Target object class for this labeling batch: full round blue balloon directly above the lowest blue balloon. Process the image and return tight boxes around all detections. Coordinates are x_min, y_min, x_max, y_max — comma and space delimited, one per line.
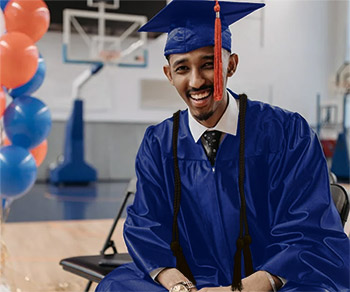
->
4, 95, 52, 149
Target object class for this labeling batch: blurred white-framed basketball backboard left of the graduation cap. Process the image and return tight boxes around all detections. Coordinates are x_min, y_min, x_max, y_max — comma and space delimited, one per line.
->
63, 0, 147, 67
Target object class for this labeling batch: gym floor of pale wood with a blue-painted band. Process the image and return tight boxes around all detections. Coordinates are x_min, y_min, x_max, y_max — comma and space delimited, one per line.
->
0, 181, 350, 292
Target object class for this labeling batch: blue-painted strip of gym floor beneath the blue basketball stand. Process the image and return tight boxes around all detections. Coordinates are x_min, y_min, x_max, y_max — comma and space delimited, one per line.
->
6, 181, 128, 222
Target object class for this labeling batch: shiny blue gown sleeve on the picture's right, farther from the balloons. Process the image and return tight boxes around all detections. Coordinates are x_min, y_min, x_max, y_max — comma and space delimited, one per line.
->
259, 114, 350, 291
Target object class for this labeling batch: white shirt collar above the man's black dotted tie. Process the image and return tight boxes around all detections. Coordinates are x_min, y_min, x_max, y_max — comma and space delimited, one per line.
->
188, 92, 239, 143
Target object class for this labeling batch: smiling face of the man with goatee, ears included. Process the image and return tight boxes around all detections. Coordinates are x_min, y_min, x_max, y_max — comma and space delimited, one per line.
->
164, 47, 238, 127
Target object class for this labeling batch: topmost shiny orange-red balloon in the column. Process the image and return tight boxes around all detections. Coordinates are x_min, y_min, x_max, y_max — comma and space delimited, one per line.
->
4, 0, 50, 43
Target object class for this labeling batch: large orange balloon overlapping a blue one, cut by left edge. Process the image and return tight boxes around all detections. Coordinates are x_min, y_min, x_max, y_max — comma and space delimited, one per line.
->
0, 32, 39, 88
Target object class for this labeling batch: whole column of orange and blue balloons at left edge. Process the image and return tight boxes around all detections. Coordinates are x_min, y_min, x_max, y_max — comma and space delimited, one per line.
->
0, 0, 51, 210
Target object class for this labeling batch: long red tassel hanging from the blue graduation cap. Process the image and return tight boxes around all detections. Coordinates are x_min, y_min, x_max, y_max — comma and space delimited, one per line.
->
214, 0, 223, 101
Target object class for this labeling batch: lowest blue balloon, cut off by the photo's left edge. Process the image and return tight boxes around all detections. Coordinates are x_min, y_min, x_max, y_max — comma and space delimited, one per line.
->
0, 145, 37, 198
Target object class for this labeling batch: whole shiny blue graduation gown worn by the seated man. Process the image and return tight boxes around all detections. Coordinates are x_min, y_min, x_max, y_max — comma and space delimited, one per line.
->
97, 100, 350, 292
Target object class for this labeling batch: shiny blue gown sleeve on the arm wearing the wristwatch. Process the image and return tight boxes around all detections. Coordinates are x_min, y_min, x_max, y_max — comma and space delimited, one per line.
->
124, 127, 176, 275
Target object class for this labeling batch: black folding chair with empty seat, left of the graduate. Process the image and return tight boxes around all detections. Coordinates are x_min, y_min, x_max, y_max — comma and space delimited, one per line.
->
60, 178, 136, 291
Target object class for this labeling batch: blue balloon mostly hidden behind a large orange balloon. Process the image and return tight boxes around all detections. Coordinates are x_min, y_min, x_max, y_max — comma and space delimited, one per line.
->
9, 55, 46, 98
